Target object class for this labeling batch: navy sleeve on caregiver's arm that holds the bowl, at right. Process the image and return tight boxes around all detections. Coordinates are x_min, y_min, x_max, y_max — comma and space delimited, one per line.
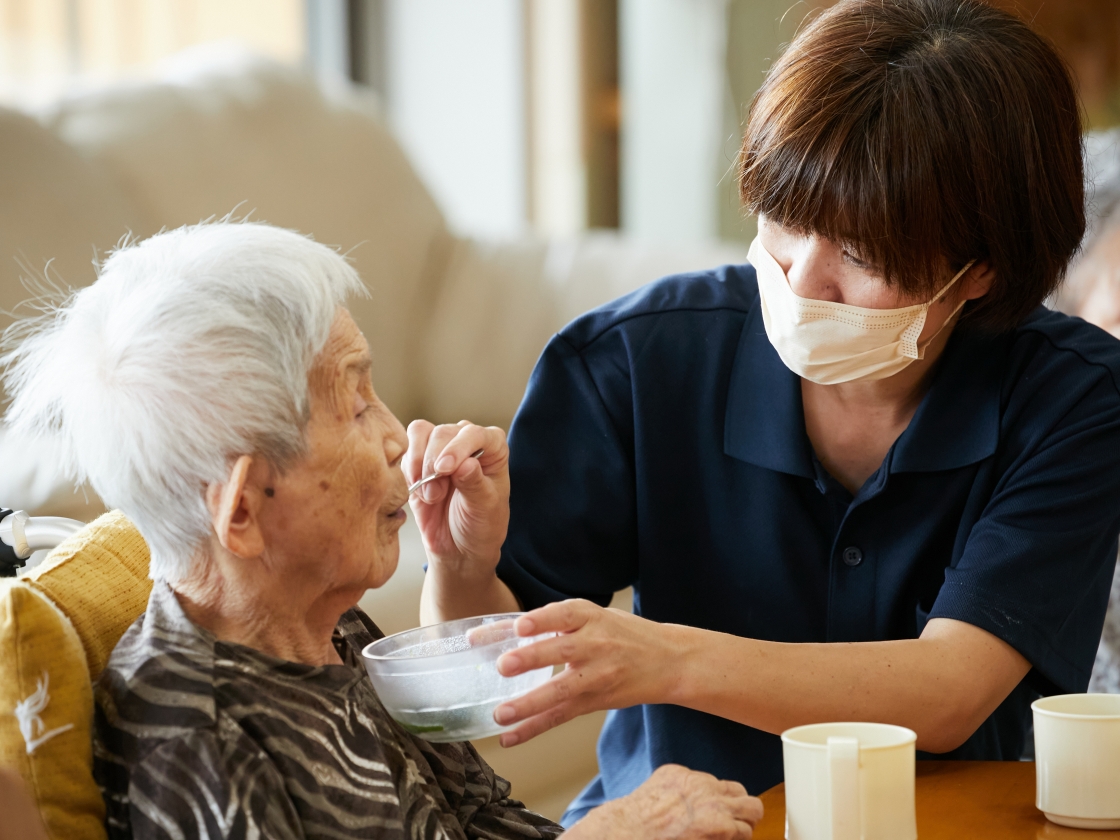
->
930, 376, 1120, 693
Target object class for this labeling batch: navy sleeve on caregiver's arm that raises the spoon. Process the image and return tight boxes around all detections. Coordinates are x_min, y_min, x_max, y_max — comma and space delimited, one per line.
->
497, 332, 637, 608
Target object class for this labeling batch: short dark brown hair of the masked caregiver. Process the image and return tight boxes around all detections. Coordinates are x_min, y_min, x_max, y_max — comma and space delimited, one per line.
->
739, 0, 1085, 329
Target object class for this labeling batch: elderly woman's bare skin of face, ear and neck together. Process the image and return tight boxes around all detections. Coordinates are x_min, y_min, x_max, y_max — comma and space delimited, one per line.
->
179, 309, 408, 665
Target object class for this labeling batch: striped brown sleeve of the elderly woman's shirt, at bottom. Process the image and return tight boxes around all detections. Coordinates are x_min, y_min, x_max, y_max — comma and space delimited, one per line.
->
123, 730, 304, 840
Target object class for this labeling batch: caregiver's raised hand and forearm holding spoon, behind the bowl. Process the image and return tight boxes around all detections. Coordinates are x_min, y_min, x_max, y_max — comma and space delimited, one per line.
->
402, 420, 521, 625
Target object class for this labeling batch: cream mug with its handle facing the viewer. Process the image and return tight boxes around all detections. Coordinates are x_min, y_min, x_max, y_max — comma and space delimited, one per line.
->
782, 724, 917, 840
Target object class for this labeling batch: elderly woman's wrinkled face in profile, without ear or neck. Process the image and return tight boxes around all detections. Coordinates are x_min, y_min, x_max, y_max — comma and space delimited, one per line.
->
262, 309, 408, 595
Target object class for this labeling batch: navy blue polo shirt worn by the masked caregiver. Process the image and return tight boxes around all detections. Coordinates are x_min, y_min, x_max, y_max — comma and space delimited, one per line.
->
498, 264, 1120, 815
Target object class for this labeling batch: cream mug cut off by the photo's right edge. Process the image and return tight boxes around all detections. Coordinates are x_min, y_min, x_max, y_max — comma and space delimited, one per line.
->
1030, 694, 1120, 829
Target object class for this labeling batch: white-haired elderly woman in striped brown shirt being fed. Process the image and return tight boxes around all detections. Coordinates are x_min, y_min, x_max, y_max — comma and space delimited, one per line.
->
7, 224, 760, 839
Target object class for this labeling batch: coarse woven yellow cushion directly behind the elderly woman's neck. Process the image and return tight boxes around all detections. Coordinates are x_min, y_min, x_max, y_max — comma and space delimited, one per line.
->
22, 511, 151, 680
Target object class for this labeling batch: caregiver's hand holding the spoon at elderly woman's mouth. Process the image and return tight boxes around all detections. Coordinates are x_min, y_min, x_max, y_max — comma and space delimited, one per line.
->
403, 420, 510, 573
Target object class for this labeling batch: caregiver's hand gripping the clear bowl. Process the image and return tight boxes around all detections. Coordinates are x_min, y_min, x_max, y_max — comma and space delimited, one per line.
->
494, 600, 679, 747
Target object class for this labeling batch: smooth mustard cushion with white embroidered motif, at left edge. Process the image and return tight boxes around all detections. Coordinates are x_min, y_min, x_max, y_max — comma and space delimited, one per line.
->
0, 580, 105, 840
